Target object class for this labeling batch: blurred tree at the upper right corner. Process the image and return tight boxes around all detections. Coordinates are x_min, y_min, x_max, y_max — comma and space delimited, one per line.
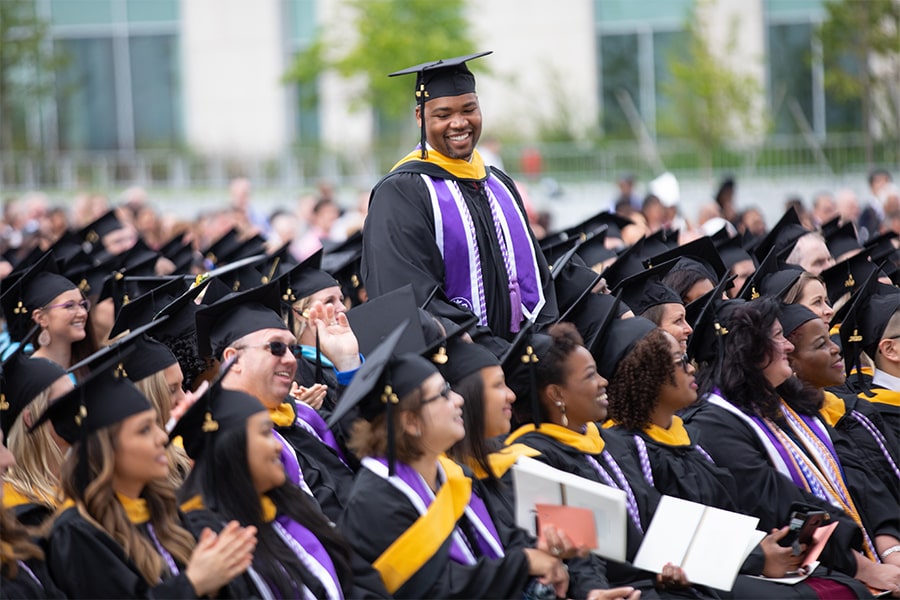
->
816, 0, 900, 165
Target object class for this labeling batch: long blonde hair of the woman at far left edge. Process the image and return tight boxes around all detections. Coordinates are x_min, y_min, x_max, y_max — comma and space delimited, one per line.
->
5, 387, 65, 508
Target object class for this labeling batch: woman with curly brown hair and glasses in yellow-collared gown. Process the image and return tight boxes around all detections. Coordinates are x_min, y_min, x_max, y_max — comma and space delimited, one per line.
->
609, 322, 866, 598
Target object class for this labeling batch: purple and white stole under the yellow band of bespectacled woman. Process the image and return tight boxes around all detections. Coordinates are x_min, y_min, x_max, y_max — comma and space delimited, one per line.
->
362, 457, 504, 565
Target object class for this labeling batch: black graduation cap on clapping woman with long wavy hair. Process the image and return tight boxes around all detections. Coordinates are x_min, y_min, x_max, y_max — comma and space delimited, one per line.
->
30, 348, 153, 446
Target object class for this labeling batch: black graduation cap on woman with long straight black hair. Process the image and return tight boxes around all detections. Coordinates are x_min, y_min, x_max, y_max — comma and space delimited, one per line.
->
169, 363, 266, 461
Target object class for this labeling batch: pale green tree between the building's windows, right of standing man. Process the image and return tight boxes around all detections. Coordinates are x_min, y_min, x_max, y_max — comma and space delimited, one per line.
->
657, 1, 765, 175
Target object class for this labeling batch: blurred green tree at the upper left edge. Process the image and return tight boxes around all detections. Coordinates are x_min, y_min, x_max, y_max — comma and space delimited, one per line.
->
0, 0, 65, 150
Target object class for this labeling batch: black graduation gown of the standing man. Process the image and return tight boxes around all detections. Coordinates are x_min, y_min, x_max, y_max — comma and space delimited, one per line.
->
362, 161, 558, 349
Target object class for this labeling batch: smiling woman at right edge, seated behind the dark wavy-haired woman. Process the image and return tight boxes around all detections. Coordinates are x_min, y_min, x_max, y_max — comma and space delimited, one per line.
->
781, 304, 900, 507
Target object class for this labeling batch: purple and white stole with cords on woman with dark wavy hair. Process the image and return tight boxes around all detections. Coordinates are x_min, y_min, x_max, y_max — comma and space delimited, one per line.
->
706, 393, 880, 562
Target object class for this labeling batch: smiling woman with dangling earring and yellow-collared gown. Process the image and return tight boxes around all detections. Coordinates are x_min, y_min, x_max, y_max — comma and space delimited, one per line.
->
504, 317, 704, 598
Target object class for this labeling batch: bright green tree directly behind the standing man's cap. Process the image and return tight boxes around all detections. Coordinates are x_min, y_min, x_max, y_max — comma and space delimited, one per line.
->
285, 0, 477, 143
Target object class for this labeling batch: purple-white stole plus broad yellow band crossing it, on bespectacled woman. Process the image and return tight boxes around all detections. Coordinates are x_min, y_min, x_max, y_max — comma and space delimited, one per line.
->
362, 456, 504, 594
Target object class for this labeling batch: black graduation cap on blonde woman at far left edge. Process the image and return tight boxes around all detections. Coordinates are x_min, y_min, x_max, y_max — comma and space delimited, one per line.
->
0, 326, 66, 438
